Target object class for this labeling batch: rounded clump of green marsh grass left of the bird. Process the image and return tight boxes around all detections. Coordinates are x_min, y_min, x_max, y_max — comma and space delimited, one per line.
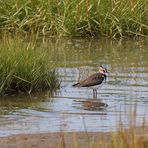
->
0, 39, 59, 95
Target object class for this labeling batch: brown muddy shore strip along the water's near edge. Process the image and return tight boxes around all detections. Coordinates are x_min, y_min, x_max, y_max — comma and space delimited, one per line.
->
0, 126, 148, 148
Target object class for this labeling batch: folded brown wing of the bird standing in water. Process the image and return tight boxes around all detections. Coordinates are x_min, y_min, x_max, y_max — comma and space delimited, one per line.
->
77, 73, 105, 87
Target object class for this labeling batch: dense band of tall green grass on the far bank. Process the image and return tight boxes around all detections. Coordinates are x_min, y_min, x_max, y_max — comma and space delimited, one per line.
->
0, 0, 148, 37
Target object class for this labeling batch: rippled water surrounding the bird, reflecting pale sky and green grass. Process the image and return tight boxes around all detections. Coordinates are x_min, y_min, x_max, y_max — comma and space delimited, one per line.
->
0, 39, 148, 136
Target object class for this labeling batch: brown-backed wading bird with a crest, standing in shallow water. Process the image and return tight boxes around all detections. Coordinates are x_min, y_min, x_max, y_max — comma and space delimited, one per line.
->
72, 65, 108, 99
